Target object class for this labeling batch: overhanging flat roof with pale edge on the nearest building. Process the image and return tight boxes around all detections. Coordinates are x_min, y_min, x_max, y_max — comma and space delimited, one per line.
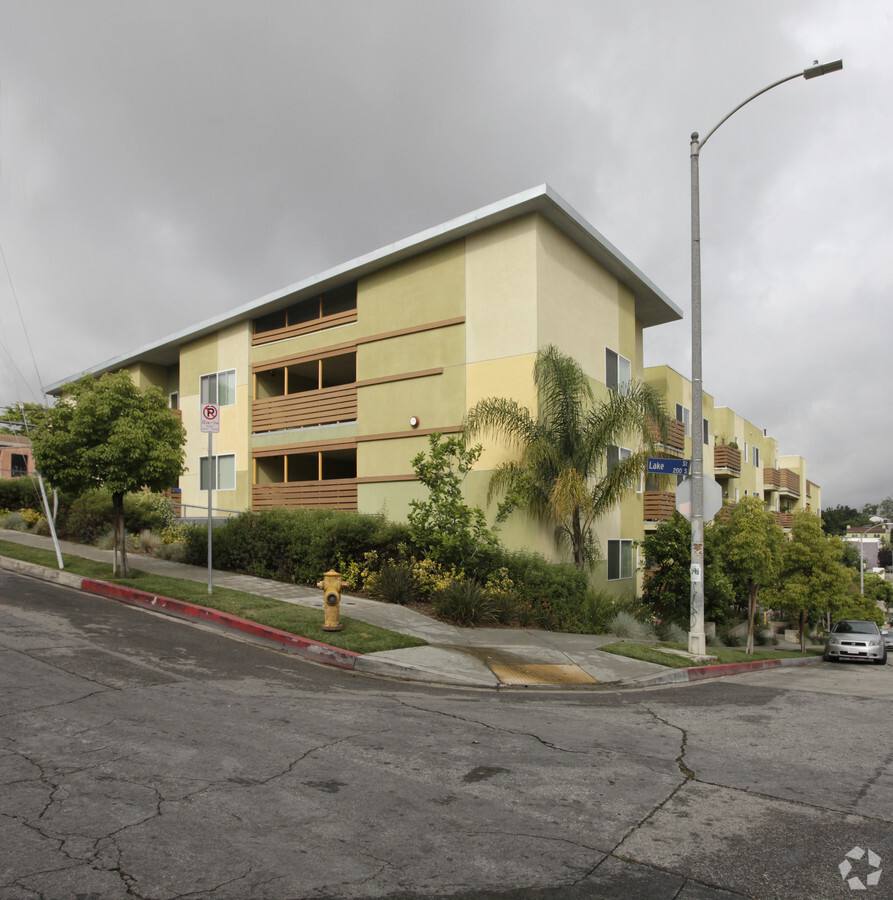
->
45, 184, 682, 394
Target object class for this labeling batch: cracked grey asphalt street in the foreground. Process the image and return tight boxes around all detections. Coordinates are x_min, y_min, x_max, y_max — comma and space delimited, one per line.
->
0, 572, 893, 900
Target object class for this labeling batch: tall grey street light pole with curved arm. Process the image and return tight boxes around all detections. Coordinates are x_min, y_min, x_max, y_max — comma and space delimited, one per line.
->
688, 59, 843, 655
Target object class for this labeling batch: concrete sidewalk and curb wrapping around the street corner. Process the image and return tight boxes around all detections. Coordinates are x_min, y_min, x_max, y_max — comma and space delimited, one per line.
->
0, 529, 820, 688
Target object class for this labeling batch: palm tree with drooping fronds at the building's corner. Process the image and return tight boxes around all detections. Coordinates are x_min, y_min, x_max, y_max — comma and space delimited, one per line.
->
465, 345, 667, 567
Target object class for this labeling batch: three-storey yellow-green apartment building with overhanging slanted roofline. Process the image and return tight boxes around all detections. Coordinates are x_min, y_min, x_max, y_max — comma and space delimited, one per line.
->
48, 186, 684, 591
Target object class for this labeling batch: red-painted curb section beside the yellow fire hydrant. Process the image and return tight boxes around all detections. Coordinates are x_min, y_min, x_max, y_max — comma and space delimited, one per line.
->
81, 578, 361, 669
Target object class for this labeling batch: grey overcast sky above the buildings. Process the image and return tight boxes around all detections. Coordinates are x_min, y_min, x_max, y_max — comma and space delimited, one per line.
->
0, 0, 893, 507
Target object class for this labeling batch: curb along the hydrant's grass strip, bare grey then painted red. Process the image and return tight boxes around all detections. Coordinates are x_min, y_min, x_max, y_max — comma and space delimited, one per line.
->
0, 557, 361, 669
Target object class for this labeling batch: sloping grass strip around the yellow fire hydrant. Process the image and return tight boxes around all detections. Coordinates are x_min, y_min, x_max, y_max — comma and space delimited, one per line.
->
0, 541, 427, 653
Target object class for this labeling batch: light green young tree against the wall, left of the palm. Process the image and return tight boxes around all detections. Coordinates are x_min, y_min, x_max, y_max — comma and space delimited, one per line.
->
407, 433, 498, 569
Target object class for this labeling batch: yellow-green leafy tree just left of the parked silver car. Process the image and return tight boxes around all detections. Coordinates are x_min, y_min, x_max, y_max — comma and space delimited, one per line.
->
767, 510, 853, 651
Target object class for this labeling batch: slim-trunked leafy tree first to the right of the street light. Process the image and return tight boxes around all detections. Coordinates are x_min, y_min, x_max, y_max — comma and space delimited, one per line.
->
715, 497, 784, 653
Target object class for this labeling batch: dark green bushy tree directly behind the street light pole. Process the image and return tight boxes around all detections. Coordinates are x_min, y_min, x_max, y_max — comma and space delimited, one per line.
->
642, 512, 733, 629
